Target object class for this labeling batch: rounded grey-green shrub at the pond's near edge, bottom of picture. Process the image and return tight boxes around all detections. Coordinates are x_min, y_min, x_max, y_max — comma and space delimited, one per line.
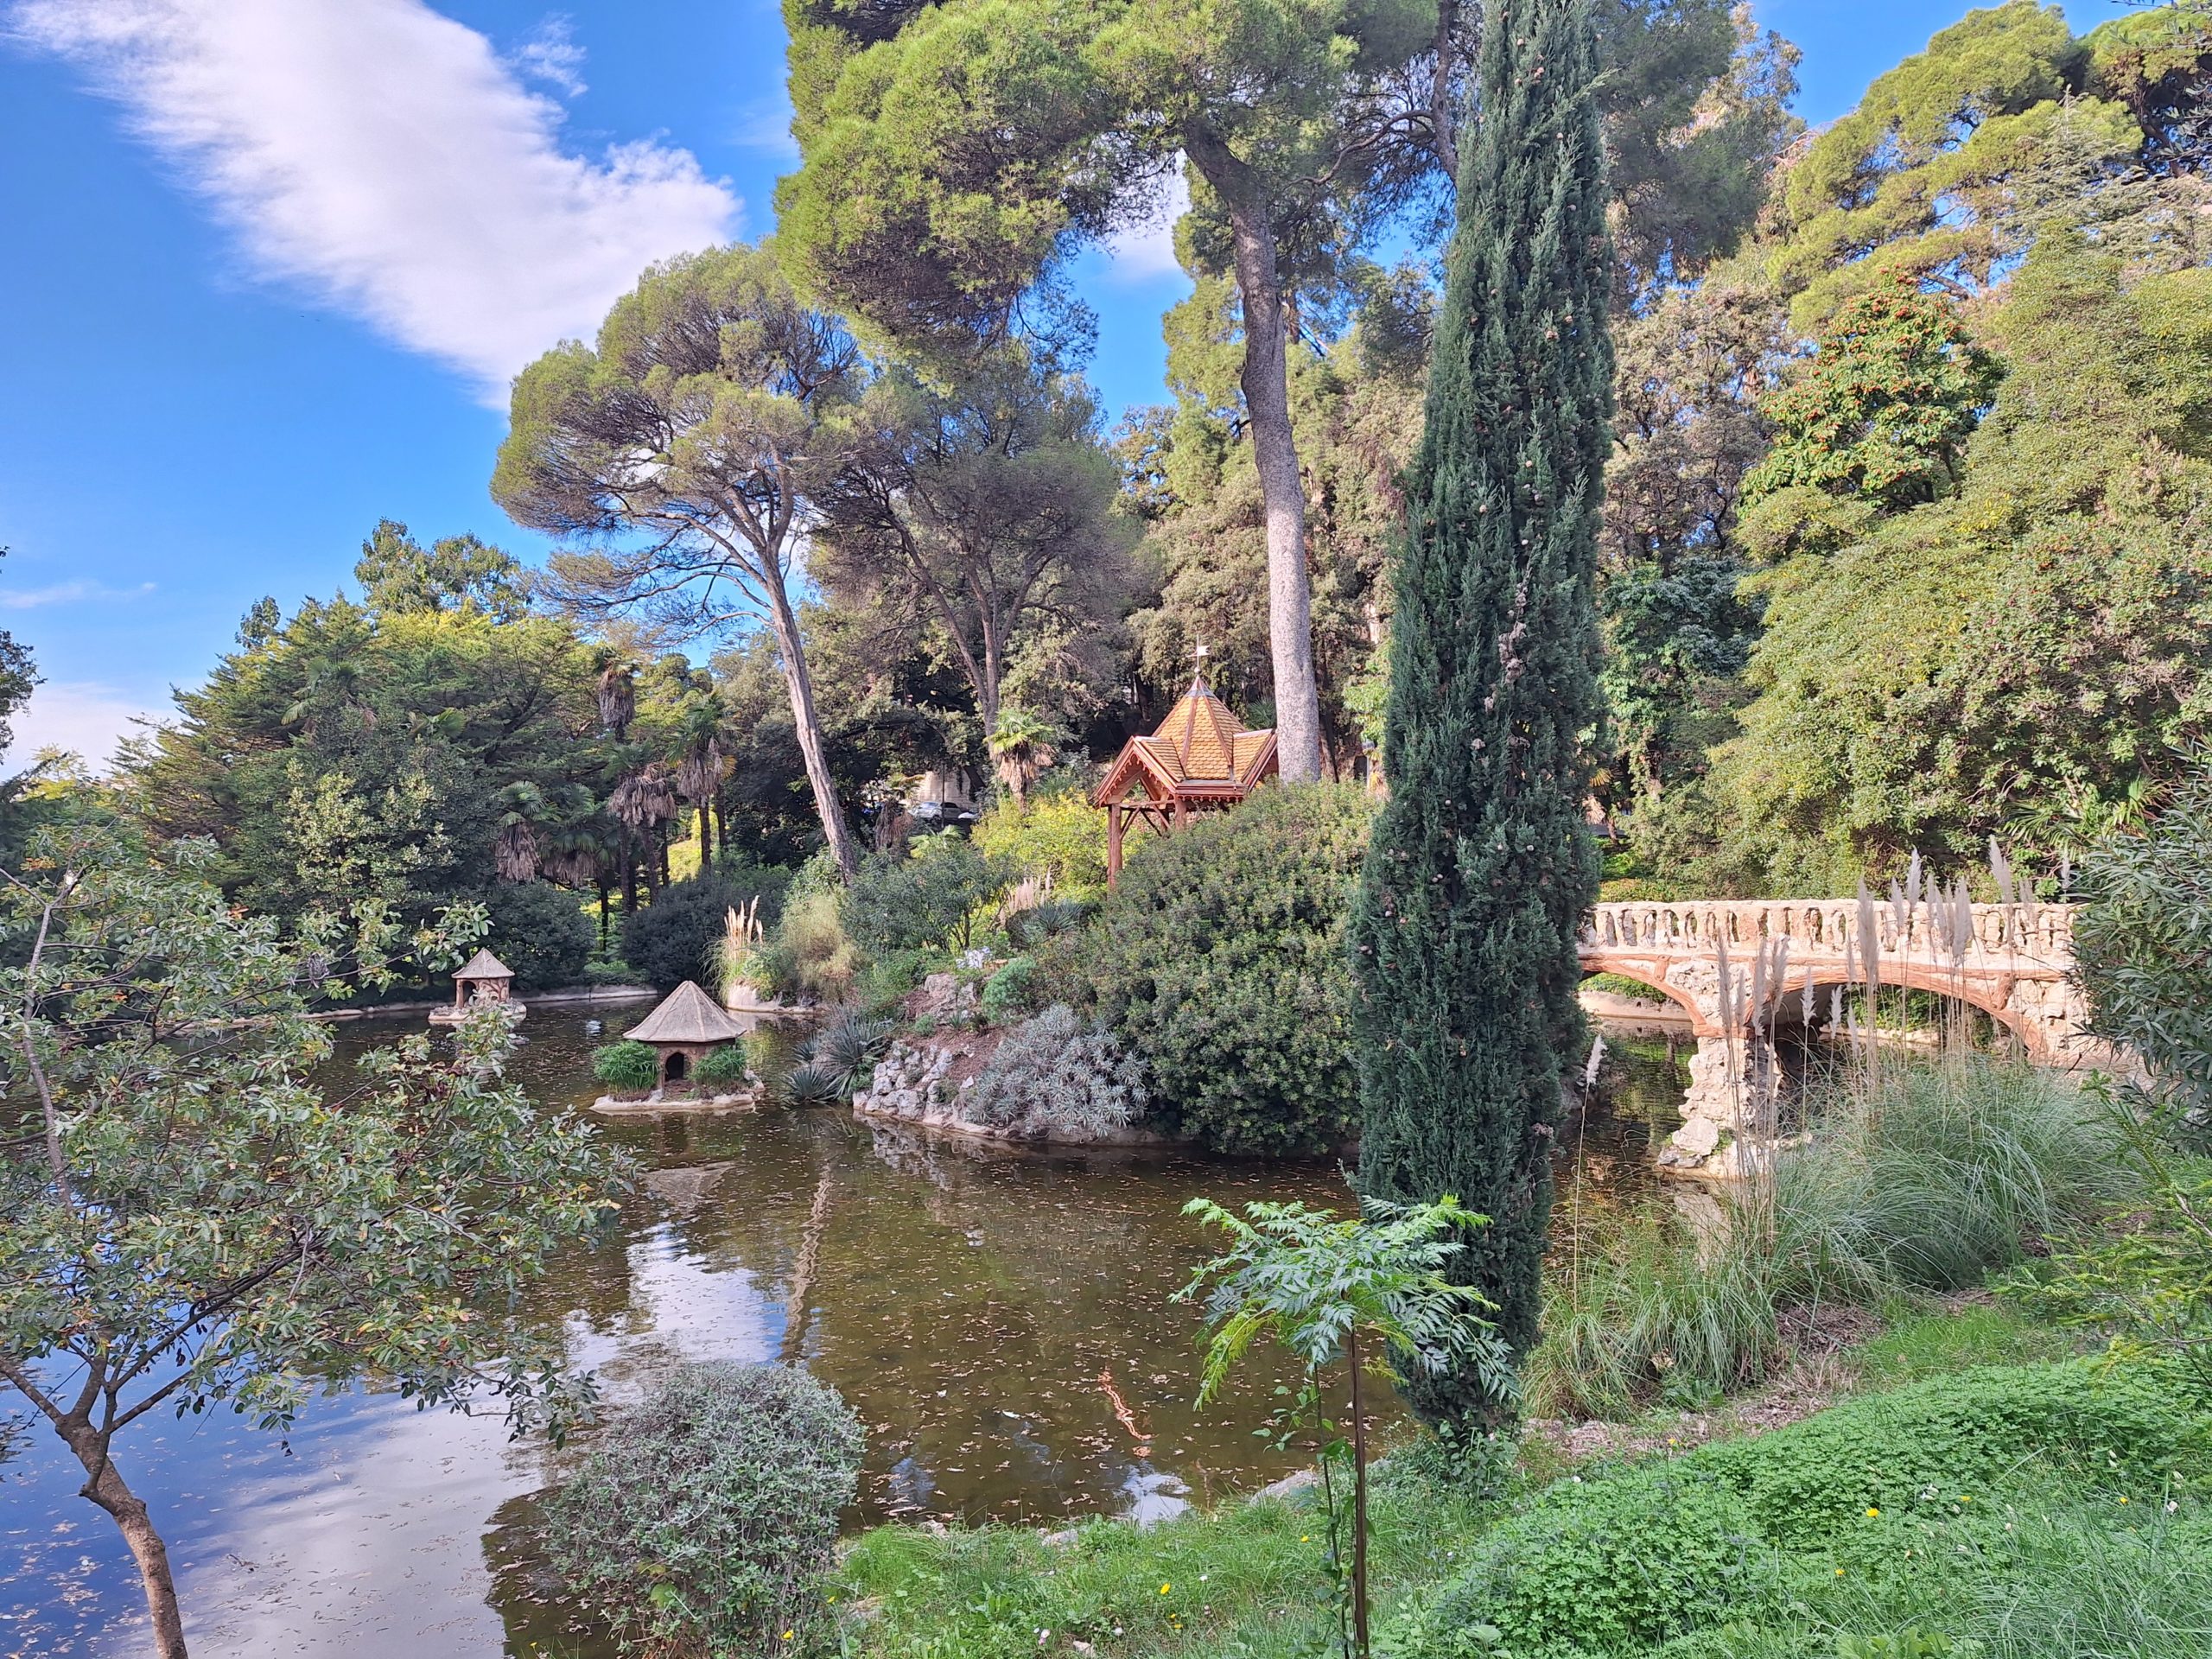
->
546, 1363, 862, 1659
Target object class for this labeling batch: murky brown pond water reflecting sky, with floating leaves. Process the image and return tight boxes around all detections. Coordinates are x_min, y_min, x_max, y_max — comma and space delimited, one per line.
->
0, 1008, 1681, 1659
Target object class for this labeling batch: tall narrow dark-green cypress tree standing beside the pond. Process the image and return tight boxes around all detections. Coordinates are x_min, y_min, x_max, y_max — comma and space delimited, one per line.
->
1351, 0, 1612, 1421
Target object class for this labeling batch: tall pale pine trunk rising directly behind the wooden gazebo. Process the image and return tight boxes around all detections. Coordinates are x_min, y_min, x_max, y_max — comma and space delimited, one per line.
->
1185, 133, 1320, 783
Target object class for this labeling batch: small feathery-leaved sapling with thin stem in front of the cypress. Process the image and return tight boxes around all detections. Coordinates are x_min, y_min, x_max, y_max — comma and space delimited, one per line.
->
1179, 1194, 1513, 1659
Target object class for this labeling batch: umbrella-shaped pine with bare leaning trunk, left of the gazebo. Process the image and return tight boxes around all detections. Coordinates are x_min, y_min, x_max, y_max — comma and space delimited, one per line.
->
491, 245, 862, 876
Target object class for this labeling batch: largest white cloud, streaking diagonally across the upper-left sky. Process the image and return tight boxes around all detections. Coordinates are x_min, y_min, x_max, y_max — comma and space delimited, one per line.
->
13, 0, 741, 403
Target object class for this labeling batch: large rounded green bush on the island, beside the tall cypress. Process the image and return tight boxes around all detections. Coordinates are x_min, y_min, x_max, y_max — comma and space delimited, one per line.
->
1044, 785, 1371, 1153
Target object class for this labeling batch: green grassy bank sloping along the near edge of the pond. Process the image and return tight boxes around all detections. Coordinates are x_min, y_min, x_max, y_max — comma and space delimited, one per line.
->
838, 1336, 2212, 1659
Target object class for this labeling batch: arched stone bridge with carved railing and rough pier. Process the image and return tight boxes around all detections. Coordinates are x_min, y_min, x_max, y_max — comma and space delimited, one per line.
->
1581, 911, 2119, 1177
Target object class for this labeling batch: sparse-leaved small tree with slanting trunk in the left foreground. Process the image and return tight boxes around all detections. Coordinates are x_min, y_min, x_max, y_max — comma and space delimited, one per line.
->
0, 825, 621, 1659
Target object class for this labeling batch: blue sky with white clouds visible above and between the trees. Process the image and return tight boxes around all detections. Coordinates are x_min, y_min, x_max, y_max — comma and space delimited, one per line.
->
0, 0, 2117, 761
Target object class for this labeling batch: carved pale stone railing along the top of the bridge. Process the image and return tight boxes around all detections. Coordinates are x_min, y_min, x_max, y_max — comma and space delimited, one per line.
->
1581, 898, 2075, 971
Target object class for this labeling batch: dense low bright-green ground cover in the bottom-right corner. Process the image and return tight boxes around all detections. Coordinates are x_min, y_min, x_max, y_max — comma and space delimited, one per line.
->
1391, 1363, 2212, 1659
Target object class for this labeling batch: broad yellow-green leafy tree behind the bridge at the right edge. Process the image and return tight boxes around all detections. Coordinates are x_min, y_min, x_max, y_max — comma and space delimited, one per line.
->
1714, 237, 2212, 892
